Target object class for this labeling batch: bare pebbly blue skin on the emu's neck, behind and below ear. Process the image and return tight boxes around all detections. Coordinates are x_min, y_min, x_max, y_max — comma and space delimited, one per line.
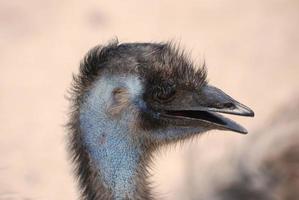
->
80, 76, 146, 200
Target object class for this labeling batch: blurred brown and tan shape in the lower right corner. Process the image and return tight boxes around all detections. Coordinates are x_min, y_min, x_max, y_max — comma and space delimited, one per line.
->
186, 97, 299, 200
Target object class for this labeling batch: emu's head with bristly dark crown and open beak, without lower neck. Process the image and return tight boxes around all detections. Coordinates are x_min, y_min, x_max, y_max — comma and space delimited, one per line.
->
75, 43, 254, 146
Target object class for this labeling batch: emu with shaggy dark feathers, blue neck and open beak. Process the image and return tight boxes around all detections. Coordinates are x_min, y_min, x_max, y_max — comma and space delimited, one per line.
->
67, 40, 254, 200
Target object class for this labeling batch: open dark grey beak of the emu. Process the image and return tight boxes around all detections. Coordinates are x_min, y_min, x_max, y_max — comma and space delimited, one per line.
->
161, 85, 254, 134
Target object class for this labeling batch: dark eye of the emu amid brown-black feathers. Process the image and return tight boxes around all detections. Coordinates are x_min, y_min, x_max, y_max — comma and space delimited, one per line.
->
154, 83, 175, 102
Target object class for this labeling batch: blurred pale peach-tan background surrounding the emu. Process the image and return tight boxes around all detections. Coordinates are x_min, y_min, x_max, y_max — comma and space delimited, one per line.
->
0, 0, 299, 200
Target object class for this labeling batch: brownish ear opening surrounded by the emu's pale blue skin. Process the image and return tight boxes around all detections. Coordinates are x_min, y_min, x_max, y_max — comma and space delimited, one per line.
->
107, 87, 129, 116
